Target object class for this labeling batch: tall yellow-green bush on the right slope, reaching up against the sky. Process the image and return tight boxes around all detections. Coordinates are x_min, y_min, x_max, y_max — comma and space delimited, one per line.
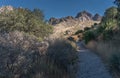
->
90, 7, 118, 40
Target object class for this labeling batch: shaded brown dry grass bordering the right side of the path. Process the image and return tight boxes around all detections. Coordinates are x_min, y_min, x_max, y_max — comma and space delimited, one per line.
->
87, 34, 120, 78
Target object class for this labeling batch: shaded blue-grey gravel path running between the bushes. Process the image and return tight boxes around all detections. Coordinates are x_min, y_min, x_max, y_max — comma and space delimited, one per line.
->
77, 43, 112, 78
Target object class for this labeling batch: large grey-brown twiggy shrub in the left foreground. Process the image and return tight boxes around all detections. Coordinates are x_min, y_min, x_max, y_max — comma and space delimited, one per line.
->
0, 31, 48, 78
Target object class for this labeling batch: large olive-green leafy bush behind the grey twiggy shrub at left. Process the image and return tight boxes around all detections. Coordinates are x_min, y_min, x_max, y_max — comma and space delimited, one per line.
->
0, 8, 53, 39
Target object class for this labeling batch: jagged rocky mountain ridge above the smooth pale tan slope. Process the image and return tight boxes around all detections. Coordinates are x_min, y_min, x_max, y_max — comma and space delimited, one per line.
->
49, 11, 102, 26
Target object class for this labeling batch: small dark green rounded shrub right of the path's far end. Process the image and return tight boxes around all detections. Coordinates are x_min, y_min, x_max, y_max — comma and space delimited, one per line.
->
84, 31, 95, 44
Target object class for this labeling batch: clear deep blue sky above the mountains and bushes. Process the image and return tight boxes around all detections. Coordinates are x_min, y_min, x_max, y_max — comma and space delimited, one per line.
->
0, 0, 114, 19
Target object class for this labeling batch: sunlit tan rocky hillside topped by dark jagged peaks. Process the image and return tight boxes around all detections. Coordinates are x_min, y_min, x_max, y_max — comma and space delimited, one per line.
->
49, 11, 102, 38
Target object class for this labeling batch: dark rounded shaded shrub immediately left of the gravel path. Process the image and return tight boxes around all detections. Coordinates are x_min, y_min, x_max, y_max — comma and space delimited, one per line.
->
47, 40, 77, 78
